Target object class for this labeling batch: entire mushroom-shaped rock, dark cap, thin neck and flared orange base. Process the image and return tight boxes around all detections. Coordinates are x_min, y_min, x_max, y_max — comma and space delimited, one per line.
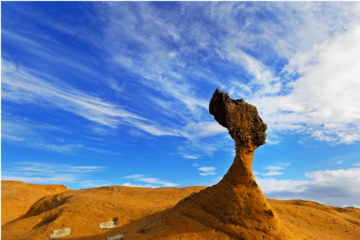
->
176, 89, 297, 240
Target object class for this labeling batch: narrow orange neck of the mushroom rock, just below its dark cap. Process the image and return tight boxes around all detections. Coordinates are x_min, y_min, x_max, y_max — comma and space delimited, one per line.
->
222, 136, 256, 184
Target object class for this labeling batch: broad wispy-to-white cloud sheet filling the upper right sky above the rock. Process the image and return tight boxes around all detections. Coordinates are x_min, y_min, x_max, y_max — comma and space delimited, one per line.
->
93, 1, 360, 143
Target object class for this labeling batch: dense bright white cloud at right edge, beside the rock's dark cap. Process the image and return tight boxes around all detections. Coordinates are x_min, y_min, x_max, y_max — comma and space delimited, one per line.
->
254, 26, 360, 143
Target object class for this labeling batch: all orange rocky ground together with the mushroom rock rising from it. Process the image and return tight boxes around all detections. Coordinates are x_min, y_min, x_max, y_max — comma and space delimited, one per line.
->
0, 89, 360, 240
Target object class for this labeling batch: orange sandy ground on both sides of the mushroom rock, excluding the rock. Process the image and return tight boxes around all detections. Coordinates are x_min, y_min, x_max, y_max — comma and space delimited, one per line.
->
0, 182, 360, 240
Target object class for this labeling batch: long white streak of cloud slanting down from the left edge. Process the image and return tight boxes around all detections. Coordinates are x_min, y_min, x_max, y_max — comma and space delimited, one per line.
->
0, 58, 179, 136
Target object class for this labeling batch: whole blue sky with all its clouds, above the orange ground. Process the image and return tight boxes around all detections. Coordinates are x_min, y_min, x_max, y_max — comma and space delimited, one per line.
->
0, 0, 360, 207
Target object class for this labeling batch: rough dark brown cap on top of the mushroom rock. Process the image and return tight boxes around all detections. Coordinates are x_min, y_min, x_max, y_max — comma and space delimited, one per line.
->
209, 88, 267, 147
